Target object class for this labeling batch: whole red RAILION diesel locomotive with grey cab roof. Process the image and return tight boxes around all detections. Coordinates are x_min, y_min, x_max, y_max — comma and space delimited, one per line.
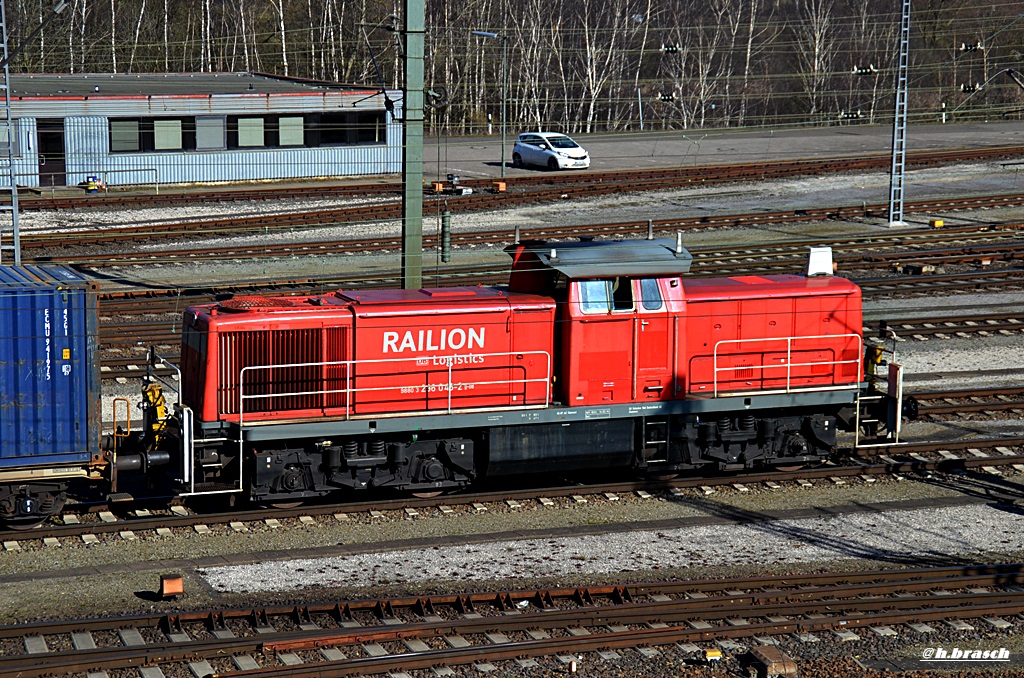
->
153, 240, 897, 507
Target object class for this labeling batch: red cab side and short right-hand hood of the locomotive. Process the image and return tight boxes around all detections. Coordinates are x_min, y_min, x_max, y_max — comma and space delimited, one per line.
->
559, 276, 862, 405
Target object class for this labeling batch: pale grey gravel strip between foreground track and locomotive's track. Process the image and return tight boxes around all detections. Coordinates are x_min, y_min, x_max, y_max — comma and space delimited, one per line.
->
201, 506, 1024, 593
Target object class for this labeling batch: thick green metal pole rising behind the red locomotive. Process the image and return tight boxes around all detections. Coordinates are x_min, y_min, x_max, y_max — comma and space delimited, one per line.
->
401, 0, 426, 290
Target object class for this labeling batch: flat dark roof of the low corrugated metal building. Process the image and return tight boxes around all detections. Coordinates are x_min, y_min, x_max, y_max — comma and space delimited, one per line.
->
10, 73, 378, 98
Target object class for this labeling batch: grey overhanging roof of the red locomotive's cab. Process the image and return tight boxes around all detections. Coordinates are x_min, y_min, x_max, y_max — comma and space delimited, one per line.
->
506, 239, 693, 279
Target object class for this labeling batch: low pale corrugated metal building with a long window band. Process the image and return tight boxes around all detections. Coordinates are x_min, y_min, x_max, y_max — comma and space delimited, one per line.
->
0, 73, 401, 186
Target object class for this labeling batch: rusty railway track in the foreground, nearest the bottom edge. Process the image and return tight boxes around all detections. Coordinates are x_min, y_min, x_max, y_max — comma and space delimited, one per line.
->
0, 564, 1024, 677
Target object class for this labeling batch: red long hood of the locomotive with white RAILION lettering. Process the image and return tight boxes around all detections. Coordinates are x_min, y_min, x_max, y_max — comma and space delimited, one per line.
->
182, 287, 555, 424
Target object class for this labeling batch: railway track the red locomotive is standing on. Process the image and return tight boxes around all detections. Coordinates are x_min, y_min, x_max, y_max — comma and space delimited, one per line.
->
0, 437, 1024, 549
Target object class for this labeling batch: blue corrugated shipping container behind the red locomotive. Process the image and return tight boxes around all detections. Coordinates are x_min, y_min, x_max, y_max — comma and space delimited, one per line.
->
0, 266, 100, 470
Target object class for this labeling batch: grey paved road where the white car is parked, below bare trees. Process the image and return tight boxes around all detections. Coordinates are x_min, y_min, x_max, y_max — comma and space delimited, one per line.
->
423, 122, 1024, 179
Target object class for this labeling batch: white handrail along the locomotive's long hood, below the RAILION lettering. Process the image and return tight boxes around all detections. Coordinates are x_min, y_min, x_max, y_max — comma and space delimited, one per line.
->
239, 351, 553, 428
